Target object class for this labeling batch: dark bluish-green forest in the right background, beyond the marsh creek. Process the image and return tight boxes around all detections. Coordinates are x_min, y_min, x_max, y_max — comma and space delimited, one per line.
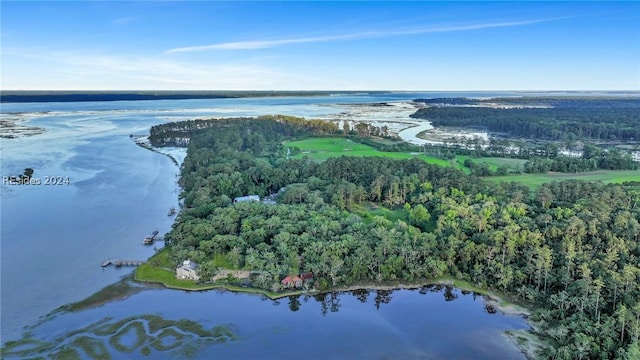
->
411, 98, 640, 141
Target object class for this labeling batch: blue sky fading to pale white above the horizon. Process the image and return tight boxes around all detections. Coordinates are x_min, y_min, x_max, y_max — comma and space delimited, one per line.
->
0, 0, 640, 91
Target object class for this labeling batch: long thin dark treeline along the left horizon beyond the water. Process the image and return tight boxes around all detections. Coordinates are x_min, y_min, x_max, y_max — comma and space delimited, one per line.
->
0, 91, 378, 103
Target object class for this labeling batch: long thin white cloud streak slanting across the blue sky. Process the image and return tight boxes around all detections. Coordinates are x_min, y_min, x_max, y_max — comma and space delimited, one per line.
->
165, 18, 559, 54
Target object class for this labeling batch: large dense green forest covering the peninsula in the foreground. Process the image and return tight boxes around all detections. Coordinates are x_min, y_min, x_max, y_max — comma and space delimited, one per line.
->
160, 118, 640, 359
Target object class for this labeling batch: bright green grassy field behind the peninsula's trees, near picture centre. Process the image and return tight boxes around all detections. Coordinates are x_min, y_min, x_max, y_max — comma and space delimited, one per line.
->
284, 138, 451, 166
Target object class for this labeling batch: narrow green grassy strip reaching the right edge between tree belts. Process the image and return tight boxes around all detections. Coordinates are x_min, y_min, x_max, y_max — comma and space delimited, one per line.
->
486, 170, 640, 189
